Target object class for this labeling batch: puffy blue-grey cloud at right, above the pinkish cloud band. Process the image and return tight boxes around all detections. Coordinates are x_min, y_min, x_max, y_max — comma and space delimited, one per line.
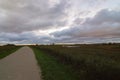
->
85, 9, 120, 25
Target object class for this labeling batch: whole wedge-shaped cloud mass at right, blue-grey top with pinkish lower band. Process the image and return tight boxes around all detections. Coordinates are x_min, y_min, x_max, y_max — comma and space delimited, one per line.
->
51, 9, 120, 42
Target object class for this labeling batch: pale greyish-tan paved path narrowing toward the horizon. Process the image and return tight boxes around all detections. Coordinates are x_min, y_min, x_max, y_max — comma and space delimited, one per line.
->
0, 47, 42, 80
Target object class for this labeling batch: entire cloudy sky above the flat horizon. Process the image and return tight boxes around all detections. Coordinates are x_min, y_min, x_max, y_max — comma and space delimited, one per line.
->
0, 0, 120, 44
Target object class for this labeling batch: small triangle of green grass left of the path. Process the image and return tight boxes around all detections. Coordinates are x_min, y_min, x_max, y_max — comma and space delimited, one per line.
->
0, 46, 20, 59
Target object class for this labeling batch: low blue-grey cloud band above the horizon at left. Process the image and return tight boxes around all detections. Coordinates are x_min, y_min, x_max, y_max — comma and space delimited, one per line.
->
0, 31, 52, 44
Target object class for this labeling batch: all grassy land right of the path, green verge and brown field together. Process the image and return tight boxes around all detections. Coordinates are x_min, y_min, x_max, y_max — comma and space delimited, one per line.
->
31, 44, 120, 80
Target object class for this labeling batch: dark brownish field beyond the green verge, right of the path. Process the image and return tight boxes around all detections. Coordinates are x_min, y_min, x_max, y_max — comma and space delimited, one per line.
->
33, 44, 120, 80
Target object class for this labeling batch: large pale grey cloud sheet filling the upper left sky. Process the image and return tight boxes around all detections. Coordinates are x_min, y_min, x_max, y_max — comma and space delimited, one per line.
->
0, 0, 68, 32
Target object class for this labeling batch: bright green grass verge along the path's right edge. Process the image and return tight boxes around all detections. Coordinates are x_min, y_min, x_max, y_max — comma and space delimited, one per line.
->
32, 47, 78, 80
